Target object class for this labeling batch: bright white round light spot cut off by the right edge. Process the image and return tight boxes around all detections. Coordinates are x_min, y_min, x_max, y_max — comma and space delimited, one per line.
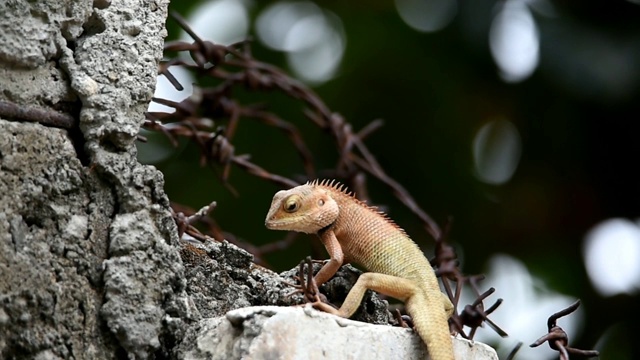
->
583, 219, 640, 296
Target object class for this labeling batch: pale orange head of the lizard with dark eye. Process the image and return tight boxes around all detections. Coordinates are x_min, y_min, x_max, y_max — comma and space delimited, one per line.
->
264, 184, 339, 234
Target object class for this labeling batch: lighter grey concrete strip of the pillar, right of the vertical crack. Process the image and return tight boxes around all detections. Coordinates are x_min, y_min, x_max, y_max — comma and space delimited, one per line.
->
56, 0, 192, 359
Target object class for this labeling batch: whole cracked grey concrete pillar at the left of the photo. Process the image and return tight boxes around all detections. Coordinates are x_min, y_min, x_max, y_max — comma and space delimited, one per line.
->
0, 0, 195, 359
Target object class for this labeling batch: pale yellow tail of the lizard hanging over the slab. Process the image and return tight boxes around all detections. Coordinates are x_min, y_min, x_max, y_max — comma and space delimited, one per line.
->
405, 294, 454, 360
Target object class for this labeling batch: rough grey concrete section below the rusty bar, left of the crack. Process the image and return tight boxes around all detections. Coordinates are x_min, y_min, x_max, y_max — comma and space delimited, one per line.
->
0, 120, 114, 359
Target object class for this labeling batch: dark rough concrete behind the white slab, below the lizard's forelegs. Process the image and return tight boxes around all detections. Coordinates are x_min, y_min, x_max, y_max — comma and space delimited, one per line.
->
180, 242, 390, 326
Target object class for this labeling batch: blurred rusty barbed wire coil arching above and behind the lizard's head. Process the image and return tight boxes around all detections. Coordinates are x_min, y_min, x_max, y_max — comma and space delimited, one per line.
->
144, 13, 440, 239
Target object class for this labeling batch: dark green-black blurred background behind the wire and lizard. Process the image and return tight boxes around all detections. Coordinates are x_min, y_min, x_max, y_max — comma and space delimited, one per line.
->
143, 0, 640, 359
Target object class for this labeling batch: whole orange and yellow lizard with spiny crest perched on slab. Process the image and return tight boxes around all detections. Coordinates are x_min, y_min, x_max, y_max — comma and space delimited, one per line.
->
265, 180, 454, 360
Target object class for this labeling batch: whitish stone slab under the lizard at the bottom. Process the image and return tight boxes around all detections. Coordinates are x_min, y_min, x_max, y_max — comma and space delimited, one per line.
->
178, 306, 498, 360
